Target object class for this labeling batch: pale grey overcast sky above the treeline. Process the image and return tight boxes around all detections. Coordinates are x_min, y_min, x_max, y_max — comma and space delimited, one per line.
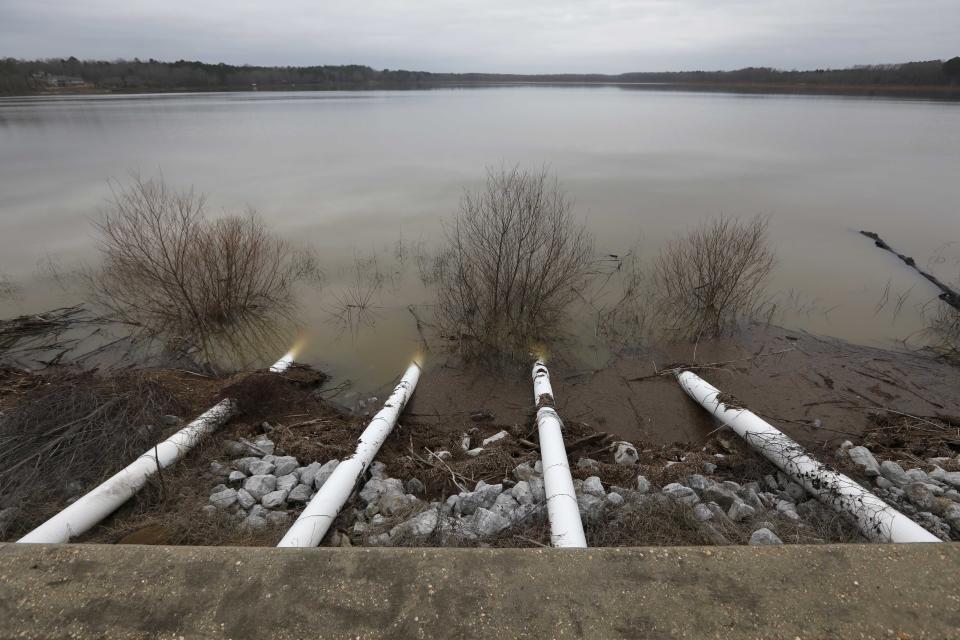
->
0, 0, 960, 73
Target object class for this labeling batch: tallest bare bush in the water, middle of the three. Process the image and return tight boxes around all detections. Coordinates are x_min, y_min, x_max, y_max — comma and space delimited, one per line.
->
434, 168, 593, 356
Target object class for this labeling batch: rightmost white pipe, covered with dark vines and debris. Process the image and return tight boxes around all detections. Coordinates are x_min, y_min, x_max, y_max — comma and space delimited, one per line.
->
677, 371, 941, 542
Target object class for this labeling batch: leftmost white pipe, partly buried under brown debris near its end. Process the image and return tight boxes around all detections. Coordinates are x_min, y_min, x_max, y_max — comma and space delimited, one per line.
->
17, 354, 293, 544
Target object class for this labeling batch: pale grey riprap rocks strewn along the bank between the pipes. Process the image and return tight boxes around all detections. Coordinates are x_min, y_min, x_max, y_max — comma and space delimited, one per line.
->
197, 422, 960, 545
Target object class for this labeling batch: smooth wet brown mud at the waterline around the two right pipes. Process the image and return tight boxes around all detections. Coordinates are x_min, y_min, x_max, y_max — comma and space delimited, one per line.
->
407, 327, 960, 450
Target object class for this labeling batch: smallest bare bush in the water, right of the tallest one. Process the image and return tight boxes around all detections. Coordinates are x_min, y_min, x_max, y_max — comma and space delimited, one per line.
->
653, 216, 775, 340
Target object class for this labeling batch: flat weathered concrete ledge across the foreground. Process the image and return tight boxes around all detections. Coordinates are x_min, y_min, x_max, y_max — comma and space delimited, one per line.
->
0, 544, 960, 640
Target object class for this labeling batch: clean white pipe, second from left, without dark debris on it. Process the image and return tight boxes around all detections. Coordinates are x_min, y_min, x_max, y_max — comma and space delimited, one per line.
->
277, 361, 420, 547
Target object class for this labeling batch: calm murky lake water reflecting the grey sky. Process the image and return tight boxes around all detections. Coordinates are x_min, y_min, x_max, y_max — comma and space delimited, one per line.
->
0, 87, 960, 388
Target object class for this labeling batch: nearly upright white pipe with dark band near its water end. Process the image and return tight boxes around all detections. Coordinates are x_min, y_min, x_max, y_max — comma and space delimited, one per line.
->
533, 360, 587, 549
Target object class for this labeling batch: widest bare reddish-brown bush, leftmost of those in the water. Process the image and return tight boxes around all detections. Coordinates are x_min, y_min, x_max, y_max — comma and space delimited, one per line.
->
85, 178, 319, 364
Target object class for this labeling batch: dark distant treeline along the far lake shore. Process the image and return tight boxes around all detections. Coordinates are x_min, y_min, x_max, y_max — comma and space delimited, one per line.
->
0, 57, 960, 95
